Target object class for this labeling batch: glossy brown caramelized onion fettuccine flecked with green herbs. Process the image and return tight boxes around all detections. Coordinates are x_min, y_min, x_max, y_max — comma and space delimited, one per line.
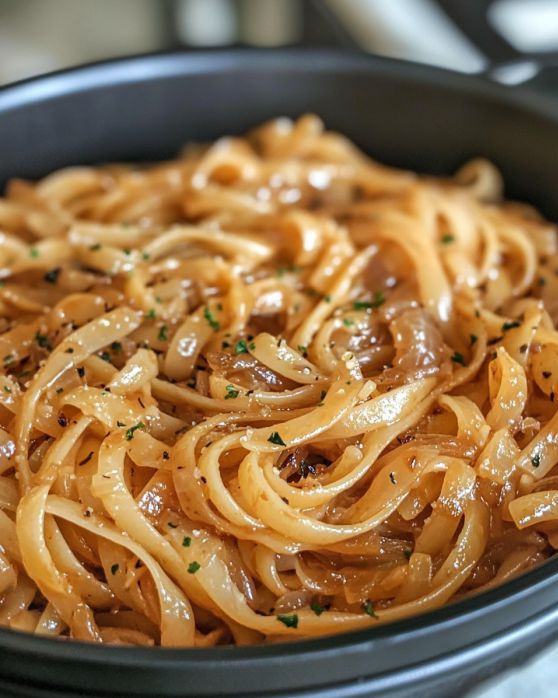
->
0, 116, 558, 647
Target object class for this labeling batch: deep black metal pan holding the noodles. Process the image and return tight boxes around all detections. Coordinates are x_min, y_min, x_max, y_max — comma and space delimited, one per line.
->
0, 42, 558, 698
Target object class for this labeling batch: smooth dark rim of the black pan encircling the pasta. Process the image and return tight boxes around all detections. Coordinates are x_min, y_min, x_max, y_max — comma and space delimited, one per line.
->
0, 48, 558, 671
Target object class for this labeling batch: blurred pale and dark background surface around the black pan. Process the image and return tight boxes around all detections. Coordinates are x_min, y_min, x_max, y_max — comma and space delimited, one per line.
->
0, 0, 558, 698
